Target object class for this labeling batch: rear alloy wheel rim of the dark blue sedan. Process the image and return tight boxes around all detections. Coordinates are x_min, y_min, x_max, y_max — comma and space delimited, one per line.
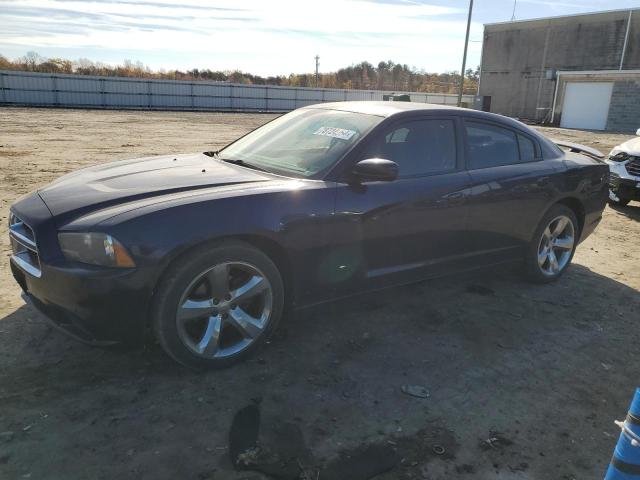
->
538, 215, 575, 276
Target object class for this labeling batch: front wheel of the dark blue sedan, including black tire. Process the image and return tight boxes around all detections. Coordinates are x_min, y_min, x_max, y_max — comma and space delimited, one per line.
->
152, 242, 284, 369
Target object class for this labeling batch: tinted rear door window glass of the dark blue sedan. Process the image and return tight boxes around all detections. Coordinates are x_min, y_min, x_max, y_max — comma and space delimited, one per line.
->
465, 122, 537, 170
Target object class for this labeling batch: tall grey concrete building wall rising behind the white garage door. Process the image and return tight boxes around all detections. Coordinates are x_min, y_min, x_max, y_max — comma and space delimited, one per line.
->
479, 9, 640, 121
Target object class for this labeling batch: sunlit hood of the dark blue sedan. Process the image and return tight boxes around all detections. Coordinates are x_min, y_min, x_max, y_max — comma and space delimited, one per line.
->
38, 153, 272, 216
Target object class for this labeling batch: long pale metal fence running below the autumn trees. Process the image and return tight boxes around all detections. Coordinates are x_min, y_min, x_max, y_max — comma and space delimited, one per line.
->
0, 70, 473, 112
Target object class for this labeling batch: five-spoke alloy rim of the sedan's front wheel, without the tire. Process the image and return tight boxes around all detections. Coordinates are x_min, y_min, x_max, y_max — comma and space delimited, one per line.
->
176, 262, 273, 358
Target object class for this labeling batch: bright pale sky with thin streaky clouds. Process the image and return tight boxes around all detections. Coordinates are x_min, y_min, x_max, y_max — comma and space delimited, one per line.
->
0, 0, 640, 76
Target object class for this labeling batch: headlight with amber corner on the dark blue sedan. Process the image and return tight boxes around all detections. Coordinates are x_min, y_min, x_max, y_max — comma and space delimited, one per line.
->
58, 232, 136, 268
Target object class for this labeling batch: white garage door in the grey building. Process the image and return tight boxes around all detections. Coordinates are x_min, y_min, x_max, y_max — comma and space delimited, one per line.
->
560, 82, 613, 130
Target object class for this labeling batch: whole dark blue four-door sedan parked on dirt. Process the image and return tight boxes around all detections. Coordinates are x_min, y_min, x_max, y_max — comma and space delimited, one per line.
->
10, 102, 608, 367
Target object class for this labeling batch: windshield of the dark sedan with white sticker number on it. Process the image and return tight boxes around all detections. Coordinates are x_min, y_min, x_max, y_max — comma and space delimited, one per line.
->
219, 108, 382, 178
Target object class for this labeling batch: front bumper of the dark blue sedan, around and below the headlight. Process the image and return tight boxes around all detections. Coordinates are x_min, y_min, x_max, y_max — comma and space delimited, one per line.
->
10, 194, 153, 345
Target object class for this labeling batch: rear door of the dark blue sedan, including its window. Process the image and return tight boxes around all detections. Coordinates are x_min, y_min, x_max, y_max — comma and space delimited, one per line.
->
464, 119, 559, 263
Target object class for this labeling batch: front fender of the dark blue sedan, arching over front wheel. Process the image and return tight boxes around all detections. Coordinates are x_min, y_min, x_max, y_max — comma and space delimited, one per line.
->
70, 182, 335, 306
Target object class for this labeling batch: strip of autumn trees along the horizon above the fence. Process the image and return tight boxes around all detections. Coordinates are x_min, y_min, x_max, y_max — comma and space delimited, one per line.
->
0, 52, 480, 94
